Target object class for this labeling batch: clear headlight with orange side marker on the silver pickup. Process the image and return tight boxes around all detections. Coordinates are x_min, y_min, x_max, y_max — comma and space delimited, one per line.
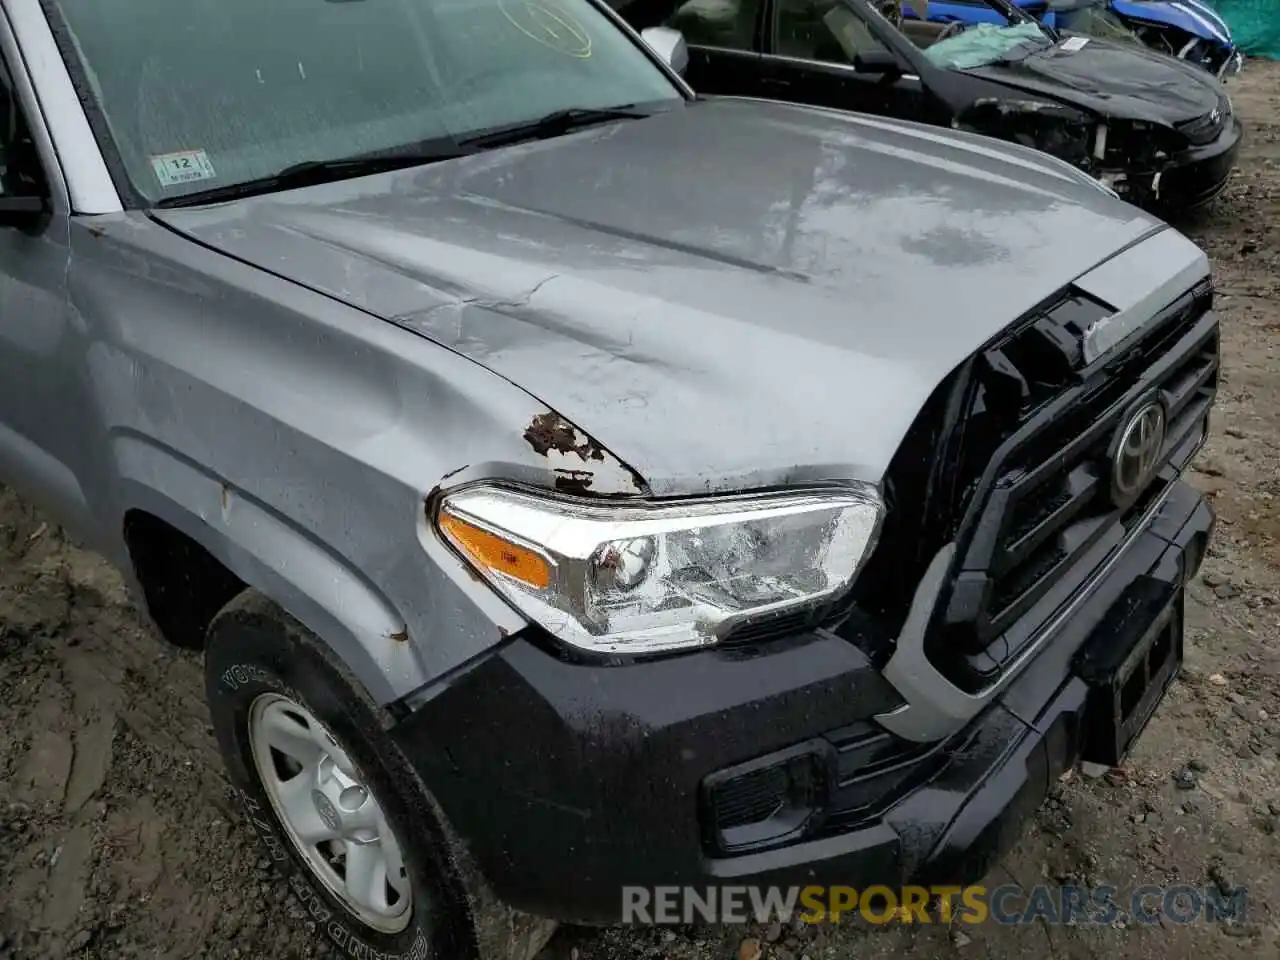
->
436, 485, 883, 653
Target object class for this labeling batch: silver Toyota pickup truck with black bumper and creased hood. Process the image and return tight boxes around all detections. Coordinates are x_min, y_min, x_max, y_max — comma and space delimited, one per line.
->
0, 0, 1219, 960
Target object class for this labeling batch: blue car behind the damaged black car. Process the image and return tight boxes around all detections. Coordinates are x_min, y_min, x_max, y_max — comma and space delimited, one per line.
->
901, 0, 1244, 78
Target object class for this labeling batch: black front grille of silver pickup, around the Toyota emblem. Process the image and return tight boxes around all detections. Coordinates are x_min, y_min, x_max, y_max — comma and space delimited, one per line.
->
835, 273, 1219, 690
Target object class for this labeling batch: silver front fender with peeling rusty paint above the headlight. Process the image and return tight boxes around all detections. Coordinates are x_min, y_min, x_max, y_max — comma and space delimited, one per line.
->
70, 215, 648, 703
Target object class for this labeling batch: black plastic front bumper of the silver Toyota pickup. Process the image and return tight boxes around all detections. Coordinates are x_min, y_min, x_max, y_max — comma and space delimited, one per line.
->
393, 484, 1213, 922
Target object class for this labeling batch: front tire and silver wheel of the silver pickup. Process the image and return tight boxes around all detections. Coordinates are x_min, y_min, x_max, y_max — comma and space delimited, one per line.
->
205, 590, 476, 960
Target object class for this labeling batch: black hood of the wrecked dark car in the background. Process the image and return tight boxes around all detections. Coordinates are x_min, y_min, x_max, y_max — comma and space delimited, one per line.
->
965, 37, 1222, 125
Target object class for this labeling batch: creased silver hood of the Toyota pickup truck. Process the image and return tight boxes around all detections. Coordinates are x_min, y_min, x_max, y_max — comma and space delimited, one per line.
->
154, 99, 1162, 494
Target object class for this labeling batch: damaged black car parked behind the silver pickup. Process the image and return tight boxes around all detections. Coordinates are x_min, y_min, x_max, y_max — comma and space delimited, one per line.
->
613, 0, 1242, 214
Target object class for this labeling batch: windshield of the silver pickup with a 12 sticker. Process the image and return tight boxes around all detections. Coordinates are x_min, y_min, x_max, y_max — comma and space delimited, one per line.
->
45, 0, 682, 202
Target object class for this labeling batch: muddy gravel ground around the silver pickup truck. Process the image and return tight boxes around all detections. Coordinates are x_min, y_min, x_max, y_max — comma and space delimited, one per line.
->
0, 61, 1280, 960
